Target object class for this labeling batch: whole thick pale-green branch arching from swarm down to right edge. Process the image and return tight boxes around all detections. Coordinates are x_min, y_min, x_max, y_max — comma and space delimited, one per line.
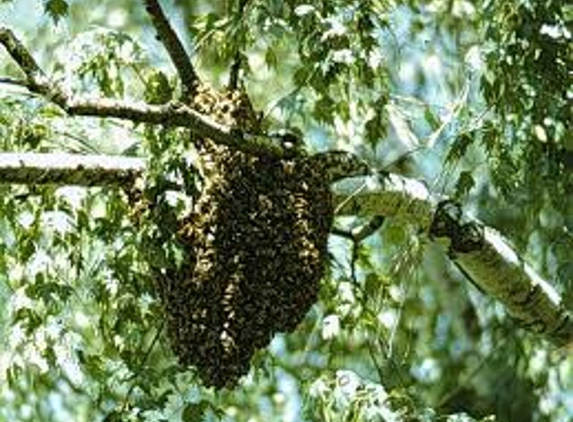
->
333, 174, 573, 346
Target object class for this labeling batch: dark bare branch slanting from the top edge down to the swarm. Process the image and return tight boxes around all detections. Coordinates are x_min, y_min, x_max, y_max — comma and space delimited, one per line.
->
143, 0, 200, 98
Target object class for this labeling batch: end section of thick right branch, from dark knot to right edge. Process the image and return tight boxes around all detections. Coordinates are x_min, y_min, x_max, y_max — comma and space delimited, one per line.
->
430, 201, 573, 346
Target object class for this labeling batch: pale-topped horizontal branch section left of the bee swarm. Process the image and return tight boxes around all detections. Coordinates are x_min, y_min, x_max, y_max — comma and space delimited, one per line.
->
0, 153, 145, 186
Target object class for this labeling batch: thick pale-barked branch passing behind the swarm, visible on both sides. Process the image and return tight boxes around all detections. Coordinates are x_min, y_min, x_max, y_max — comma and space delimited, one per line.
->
0, 152, 573, 345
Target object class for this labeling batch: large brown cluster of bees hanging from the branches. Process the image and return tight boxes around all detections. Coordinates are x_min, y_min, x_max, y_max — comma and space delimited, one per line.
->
150, 83, 333, 388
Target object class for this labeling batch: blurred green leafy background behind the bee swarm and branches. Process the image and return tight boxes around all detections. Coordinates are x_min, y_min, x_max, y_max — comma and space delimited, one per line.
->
0, 0, 573, 421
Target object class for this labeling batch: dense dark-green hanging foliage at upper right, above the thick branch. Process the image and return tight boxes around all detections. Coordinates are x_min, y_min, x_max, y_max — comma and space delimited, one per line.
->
482, 1, 573, 304
